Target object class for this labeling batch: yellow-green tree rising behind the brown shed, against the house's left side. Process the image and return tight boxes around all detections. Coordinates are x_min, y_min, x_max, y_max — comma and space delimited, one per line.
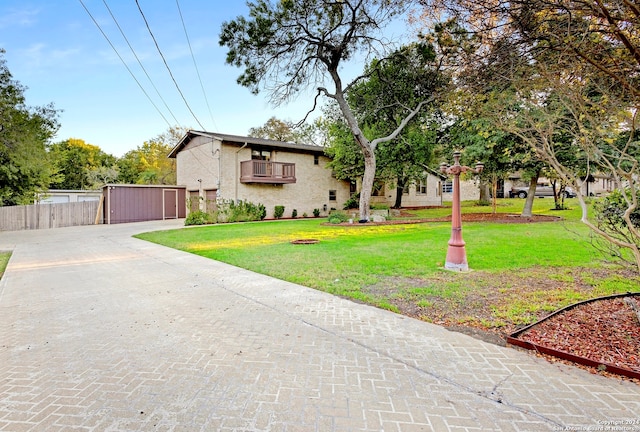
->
118, 127, 187, 185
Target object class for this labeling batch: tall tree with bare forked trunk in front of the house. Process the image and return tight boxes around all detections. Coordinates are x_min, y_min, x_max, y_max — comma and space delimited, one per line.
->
220, 0, 426, 220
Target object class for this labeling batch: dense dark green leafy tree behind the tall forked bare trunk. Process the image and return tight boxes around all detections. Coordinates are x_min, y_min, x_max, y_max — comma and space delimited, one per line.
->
322, 43, 448, 208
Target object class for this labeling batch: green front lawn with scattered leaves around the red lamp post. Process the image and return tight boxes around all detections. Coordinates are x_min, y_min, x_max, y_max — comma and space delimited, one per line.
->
138, 199, 639, 330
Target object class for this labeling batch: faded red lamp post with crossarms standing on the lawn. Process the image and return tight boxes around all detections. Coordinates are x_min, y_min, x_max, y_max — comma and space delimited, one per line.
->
440, 151, 484, 272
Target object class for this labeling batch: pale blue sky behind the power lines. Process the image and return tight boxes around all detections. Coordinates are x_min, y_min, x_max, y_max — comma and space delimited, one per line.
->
0, 0, 340, 156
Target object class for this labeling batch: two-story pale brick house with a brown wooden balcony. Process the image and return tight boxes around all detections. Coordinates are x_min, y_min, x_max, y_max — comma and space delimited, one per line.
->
169, 131, 352, 219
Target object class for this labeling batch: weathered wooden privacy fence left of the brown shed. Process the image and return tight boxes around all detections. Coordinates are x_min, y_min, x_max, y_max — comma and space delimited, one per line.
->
0, 201, 102, 231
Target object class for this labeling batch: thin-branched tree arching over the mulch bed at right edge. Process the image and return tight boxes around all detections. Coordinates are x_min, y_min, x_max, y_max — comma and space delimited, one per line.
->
424, 0, 640, 271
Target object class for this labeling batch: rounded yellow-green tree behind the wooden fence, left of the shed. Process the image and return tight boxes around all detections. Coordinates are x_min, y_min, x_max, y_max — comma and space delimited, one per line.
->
49, 138, 116, 190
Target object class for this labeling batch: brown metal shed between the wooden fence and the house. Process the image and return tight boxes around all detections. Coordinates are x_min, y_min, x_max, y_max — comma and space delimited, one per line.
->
102, 184, 187, 224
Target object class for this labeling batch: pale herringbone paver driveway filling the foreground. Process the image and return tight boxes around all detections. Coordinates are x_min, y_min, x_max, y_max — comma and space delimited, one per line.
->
0, 221, 640, 431
